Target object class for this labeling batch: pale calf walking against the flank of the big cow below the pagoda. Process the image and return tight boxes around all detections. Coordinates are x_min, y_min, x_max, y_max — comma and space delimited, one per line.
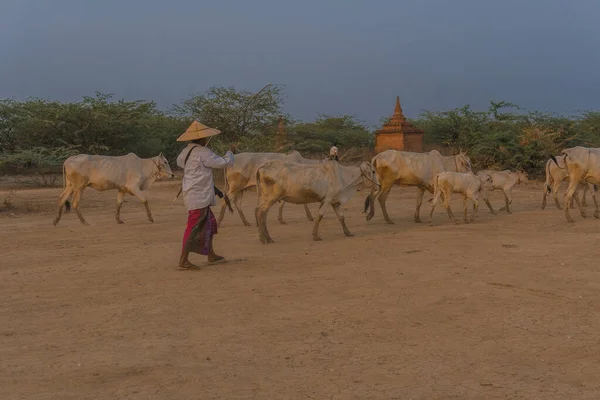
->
429, 171, 492, 225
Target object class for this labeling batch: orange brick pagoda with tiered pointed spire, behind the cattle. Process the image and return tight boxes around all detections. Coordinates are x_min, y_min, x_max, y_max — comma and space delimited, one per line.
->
375, 97, 425, 153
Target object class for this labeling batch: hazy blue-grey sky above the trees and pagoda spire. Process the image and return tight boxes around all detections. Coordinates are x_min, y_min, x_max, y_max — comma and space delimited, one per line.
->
0, 0, 600, 125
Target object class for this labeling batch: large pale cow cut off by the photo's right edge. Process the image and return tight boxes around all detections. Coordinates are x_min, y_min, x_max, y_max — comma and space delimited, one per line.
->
550, 146, 600, 222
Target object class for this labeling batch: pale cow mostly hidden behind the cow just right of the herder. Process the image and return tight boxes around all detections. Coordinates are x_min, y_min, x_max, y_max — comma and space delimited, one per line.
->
217, 150, 323, 226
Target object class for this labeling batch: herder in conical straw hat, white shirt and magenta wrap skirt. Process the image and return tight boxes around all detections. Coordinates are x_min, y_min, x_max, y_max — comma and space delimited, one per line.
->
177, 121, 233, 269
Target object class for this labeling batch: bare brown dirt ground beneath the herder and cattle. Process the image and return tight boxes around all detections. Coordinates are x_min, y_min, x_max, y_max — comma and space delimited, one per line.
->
0, 181, 600, 400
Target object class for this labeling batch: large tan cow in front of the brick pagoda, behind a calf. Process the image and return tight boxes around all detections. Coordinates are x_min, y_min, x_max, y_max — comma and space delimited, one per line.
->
364, 150, 471, 224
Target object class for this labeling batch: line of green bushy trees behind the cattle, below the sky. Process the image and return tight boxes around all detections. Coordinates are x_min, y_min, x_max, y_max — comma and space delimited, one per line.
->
0, 86, 600, 184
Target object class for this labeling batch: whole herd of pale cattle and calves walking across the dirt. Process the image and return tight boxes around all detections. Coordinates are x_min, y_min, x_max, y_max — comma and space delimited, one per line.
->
54, 147, 600, 243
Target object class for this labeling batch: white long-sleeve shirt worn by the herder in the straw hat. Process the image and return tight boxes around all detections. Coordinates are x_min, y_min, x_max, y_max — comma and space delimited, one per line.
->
177, 143, 233, 211
